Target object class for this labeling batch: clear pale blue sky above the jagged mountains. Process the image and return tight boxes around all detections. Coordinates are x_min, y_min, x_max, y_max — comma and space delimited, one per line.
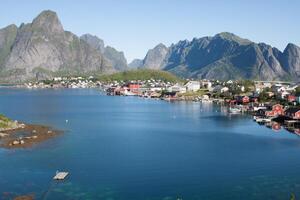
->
0, 0, 300, 62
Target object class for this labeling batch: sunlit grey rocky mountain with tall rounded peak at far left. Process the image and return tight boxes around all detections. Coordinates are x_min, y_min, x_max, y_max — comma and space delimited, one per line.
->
0, 11, 112, 82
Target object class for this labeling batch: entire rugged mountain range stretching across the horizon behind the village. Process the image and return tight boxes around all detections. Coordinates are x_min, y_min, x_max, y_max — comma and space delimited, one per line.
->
0, 10, 300, 82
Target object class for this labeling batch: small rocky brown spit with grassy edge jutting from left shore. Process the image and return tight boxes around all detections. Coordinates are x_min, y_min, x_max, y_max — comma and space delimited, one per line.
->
0, 114, 62, 148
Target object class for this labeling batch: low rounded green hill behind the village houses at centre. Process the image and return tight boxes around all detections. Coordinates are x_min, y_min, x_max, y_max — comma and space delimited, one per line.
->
97, 69, 182, 83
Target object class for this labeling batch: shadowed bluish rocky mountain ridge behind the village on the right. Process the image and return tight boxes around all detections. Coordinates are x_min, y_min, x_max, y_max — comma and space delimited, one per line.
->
142, 32, 300, 80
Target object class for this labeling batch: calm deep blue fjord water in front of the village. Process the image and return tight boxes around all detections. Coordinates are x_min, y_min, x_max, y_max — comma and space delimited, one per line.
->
0, 89, 300, 200
